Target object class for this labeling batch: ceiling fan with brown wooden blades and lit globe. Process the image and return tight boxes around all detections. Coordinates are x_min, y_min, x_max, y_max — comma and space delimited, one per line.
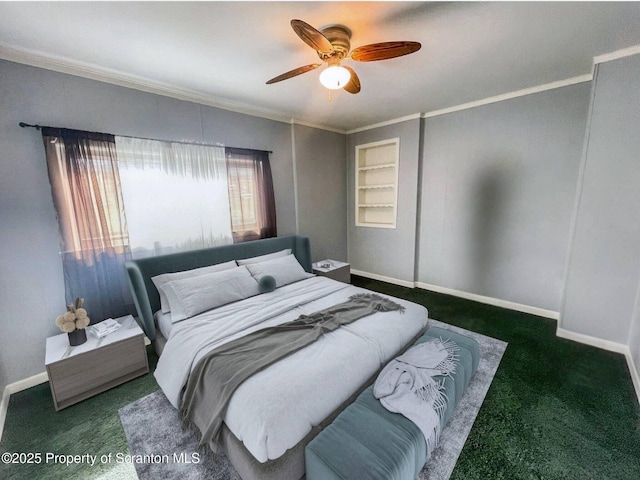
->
267, 19, 422, 93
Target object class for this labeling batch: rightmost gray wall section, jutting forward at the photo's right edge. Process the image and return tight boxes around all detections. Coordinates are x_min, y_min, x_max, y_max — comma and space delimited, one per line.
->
560, 55, 640, 348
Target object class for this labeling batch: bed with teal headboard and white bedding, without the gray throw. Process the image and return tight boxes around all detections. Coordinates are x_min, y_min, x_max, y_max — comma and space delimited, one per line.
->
126, 235, 428, 480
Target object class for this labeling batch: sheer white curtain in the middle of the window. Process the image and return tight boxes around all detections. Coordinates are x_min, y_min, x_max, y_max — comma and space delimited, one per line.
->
115, 136, 233, 258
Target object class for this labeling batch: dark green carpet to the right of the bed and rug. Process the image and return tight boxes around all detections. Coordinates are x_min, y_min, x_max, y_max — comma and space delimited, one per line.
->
353, 277, 640, 480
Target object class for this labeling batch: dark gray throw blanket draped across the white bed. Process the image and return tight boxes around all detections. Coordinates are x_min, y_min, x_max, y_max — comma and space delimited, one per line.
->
180, 293, 404, 453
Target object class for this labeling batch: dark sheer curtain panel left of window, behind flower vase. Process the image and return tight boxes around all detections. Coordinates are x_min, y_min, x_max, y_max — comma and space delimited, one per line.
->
42, 128, 135, 323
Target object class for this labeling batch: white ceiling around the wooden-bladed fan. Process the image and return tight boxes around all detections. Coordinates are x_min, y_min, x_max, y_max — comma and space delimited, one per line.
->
0, 1, 640, 131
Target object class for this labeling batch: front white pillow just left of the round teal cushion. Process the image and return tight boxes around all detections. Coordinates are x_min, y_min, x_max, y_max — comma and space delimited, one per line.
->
162, 267, 260, 323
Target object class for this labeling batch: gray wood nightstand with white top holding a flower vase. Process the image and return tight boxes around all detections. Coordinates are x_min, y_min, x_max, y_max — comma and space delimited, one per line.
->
45, 315, 149, 410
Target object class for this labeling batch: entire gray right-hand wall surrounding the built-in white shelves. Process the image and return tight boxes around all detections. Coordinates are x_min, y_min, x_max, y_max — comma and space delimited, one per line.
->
347, 60, 640, 388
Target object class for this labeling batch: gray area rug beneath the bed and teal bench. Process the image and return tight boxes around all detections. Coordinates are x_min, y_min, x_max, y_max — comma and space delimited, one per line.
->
119, 320, 507, 480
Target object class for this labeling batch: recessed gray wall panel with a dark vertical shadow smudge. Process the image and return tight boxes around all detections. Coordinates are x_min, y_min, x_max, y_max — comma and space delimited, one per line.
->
417, 82, 590, 312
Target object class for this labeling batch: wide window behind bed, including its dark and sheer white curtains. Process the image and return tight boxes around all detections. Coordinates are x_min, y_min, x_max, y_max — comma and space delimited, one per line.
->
42, 128, 276, 322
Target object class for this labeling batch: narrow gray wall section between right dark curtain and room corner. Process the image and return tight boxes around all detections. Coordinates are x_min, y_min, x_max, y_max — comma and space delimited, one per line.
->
293, 125, 347, 262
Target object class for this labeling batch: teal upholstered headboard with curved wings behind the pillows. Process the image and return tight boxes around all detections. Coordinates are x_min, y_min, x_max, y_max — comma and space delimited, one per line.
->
125, 235, 312, 340
